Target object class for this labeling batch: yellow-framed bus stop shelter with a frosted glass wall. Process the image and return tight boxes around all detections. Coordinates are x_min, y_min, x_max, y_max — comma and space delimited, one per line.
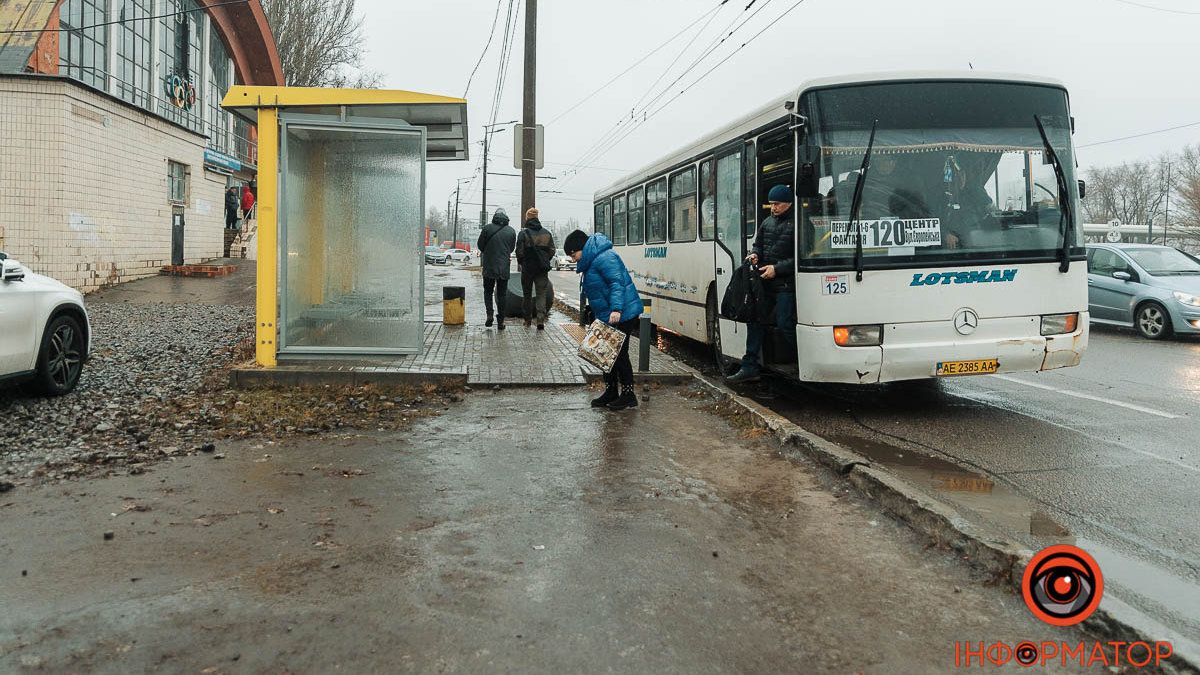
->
222, 86, 468, 368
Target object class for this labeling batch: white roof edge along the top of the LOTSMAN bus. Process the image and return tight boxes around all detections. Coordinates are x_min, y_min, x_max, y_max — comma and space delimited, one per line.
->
595, 70, 1066, 197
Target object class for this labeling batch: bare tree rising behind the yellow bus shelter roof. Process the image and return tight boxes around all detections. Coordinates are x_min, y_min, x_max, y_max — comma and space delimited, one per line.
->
262, 0, 383, 89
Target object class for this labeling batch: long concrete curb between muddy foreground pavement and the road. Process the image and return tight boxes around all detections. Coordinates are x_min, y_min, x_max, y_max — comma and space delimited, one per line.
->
692, 371, 1200, 674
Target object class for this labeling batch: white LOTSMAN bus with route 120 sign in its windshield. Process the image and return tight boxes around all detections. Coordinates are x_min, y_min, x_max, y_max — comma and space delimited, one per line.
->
595, 72, 1088, 383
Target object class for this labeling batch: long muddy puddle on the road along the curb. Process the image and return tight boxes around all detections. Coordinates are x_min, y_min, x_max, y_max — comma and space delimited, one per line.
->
829, 436, 1074, 545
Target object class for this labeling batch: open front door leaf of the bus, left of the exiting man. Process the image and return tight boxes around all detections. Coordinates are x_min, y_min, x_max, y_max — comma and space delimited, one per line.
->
709, 145, 754, 358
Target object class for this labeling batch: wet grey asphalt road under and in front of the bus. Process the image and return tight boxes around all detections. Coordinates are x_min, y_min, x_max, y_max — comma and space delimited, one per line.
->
619, 283, 1200, 659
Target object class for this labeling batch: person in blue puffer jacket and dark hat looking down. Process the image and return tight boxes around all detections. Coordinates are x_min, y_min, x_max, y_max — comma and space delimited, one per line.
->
563, 229, 642, 410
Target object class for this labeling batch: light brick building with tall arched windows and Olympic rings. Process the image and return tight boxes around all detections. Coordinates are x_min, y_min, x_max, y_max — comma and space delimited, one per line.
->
0, 0, 283, 292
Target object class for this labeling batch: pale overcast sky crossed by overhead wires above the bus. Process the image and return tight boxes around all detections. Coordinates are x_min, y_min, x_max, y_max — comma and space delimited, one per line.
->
359, 0, 1200, 223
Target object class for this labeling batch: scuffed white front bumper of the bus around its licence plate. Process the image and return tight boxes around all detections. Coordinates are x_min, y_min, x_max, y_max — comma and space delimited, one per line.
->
796, 312, 1088, 384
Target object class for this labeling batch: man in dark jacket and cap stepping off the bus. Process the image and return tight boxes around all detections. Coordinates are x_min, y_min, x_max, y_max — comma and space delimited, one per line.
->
728, 185, 796, 383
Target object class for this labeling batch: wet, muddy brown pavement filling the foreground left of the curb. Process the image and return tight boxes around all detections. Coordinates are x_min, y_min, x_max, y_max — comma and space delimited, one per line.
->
0, 387, 1082, 674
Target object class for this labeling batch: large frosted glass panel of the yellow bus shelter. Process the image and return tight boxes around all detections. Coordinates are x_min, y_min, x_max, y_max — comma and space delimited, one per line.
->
281, 124, 425, 354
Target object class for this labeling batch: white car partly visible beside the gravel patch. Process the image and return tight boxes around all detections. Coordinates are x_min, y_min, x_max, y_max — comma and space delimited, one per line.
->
0, 253, 91, 396
